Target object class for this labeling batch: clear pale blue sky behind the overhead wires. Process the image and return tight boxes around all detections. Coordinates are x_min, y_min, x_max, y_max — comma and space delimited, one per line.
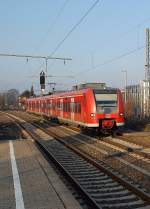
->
0, 0, 150, 91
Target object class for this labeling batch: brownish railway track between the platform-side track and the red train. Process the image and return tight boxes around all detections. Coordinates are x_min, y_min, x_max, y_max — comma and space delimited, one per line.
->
7, 114, 150, 189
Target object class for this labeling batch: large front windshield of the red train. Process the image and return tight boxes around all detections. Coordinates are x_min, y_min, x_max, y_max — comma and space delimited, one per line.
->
95, 93, 117, 114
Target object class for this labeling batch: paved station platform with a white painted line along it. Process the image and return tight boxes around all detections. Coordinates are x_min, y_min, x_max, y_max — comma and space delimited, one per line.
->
0, 139, 82, 209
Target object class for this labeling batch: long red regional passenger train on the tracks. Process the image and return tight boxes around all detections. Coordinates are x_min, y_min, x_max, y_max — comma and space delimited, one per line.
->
27, 83, 124, 131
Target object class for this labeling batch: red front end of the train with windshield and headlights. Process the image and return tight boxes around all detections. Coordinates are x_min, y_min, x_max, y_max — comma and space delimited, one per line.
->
93, 89, 125, 130
